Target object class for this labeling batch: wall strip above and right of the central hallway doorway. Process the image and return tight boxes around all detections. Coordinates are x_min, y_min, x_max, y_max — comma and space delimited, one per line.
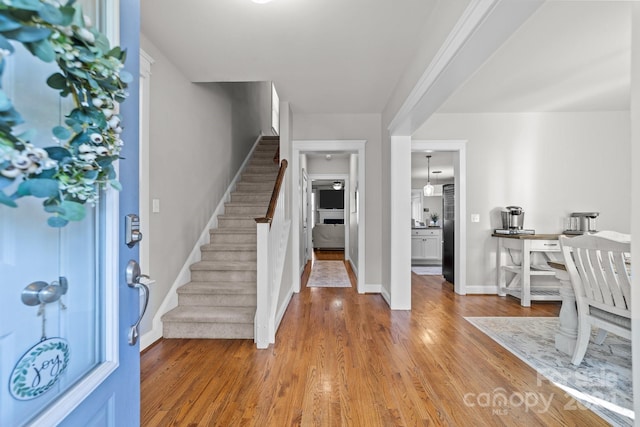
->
293, 113, 383, 285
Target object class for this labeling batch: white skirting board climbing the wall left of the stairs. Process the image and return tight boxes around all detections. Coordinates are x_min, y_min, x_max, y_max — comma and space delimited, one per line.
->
140, 133, 263, 351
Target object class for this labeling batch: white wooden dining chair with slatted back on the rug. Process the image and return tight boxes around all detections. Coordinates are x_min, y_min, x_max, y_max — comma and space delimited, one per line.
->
560, 231, 631, 366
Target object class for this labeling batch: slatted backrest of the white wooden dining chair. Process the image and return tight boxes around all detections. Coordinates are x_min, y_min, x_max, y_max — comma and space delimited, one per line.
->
560, 232, 631, 312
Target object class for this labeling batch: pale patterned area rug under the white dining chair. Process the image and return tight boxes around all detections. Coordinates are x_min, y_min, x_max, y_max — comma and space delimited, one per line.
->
465, 317, 633, 426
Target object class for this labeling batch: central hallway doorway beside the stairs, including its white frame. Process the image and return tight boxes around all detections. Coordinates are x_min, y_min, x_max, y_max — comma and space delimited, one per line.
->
292, 141, 366, 293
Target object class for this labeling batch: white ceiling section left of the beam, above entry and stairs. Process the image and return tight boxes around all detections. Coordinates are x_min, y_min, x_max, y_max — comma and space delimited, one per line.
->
141, 0, 438, 113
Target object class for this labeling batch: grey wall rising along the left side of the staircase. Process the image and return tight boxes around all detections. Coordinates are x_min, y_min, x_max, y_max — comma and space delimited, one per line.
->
140, 35, 269, 334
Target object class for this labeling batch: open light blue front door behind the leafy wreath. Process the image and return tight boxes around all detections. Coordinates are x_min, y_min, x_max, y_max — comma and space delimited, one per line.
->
0, 0, 144, 427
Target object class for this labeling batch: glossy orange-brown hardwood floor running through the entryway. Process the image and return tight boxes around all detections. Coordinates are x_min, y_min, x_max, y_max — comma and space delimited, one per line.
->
141, 260, 607, 427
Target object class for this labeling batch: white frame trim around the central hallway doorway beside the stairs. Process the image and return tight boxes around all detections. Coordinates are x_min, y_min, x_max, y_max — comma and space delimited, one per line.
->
291, 140, 364, 294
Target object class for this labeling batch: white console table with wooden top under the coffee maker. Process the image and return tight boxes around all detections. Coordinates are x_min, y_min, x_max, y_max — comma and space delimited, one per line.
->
493, 234, 562, 307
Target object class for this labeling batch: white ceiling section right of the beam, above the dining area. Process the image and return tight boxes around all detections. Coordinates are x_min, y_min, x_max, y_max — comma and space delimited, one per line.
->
439, 1, 631, 113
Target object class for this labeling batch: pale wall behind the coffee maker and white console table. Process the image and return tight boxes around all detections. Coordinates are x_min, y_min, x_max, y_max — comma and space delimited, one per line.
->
414, 112, 631, 286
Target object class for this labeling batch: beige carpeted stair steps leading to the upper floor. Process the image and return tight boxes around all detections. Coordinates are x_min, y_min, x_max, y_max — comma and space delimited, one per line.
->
162, 137, 279, 339
